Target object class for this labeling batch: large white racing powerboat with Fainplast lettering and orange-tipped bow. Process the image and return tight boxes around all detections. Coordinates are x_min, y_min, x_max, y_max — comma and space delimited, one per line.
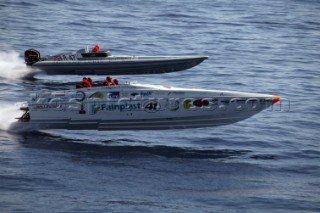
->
12, 84, 280, 130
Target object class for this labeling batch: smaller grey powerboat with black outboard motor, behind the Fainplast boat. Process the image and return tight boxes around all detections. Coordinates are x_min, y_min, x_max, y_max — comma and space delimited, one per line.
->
24, 45, 208, 75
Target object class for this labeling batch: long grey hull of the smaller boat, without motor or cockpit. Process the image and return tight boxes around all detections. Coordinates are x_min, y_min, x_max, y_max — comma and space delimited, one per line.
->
31, 56, 208, 75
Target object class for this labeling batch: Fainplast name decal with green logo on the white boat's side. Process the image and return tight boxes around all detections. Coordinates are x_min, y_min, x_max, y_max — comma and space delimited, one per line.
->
91, 103, 141, 114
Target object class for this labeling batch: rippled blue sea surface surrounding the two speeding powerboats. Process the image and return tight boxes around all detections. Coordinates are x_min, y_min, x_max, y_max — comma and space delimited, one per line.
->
0, 0, 320, 213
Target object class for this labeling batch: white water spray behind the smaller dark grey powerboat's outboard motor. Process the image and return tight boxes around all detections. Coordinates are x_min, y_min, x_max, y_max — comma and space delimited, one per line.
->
0, 51, 34, 79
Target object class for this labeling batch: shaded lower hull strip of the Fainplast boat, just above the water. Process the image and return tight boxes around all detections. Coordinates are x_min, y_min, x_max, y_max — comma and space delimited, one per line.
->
15, 113, 262, 131
